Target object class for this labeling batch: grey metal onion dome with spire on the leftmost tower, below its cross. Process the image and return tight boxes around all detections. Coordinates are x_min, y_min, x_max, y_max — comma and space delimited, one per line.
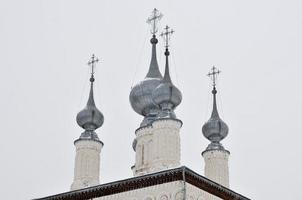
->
77, 76, 104, 132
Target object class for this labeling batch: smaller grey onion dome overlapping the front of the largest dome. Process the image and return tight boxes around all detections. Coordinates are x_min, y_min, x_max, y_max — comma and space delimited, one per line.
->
153, 49, 182, 118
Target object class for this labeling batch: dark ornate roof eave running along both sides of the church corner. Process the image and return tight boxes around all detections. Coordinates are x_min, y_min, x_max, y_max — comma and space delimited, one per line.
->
36, 166, 250, 200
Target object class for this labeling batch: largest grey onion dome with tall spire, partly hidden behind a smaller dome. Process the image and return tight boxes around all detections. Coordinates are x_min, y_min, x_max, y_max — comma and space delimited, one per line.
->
129, 35, 162, 119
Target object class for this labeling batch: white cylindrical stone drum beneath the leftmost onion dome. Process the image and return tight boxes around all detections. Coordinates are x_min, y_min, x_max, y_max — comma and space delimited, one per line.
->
71, 140, 103, 190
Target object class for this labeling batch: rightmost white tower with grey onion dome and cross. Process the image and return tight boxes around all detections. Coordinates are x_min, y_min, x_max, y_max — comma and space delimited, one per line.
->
202, 67, 230, 197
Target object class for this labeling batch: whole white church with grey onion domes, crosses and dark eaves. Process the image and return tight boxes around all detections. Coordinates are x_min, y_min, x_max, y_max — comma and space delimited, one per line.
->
37, 9, 249, 200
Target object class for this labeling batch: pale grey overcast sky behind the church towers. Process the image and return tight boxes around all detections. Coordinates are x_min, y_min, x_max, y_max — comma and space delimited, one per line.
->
0, 0, 302, 200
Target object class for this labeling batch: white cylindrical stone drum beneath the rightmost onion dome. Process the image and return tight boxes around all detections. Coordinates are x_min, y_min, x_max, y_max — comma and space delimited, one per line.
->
203, 150, 230, 200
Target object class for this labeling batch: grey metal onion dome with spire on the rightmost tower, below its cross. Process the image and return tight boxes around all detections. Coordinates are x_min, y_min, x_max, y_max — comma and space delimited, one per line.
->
202, 87, 229, 150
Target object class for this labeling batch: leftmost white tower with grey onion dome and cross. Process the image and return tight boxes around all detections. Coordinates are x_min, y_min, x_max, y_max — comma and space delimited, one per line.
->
71, 55, 104, 190
